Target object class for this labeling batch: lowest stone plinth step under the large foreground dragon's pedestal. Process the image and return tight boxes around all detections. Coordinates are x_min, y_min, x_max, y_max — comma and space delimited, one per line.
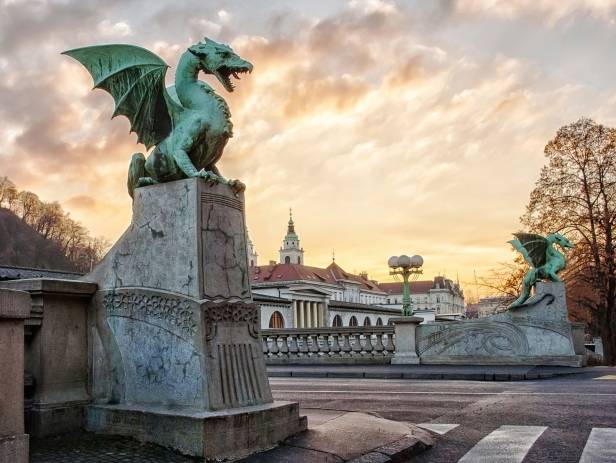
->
88, 402, 306, 460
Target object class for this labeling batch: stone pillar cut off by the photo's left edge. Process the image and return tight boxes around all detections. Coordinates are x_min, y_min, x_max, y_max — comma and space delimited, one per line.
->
0, 289, 30, 463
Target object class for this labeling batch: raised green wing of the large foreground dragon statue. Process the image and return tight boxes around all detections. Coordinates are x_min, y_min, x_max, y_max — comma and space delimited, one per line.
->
63, 44, 179, 149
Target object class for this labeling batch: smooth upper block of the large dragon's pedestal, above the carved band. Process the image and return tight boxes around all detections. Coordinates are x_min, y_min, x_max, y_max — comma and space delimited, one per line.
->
85, 178, 251, 301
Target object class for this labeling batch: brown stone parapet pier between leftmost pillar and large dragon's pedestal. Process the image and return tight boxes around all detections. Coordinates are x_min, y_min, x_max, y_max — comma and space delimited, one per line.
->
0, 278, 96, 437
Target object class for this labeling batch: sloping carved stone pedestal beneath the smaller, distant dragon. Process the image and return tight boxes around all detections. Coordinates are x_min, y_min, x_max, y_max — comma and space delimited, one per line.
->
417, 282, 582, 366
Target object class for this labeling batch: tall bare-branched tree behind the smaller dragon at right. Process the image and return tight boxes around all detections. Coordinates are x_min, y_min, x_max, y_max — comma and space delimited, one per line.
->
522, 119, 616, 365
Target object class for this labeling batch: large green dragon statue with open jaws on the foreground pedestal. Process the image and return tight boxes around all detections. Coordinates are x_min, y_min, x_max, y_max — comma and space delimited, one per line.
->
64, 38, 252, 197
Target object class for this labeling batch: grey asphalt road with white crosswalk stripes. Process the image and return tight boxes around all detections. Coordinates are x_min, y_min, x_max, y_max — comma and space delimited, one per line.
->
270, 367, 616, 463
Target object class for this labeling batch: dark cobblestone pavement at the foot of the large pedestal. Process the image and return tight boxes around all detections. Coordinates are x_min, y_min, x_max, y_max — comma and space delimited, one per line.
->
30, 433, 199, 463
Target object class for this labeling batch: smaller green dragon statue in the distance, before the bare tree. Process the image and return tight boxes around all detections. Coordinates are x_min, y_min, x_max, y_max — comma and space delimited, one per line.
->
509, 233, 573, 309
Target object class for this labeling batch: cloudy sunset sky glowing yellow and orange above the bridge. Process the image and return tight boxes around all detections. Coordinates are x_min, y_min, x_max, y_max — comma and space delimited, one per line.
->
0, 0, 616, 292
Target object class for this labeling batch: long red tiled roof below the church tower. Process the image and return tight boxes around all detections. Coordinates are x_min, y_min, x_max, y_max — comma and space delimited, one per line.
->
250, 262, 382, 292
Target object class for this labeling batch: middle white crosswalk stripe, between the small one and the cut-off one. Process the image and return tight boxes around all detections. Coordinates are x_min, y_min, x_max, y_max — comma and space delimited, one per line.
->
458, 426, 547, 463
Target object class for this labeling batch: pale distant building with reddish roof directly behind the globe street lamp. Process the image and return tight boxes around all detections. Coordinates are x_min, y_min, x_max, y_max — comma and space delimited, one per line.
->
379, 276, 464, 317
